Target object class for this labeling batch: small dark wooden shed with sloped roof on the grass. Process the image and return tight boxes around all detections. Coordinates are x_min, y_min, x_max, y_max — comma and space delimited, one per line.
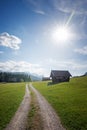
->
50, 70, 72, 83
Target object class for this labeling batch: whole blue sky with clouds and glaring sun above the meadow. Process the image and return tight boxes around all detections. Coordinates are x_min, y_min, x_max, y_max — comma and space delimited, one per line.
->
0, 0, 87, 76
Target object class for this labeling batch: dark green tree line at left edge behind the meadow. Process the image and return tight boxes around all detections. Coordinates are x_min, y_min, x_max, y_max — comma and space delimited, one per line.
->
0, 72, 31, 82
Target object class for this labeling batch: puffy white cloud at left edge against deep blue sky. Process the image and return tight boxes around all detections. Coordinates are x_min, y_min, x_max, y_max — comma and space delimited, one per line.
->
0, 32, 22, 50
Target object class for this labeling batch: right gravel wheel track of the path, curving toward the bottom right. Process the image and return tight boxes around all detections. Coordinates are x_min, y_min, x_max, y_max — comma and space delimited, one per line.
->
29, 84, 65, 130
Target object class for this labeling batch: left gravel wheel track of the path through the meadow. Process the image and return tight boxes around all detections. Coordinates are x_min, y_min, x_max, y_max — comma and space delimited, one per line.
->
4, 84, 30, 130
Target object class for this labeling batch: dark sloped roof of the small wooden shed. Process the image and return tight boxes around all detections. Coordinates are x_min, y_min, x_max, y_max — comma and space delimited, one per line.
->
50, 70, 72, 77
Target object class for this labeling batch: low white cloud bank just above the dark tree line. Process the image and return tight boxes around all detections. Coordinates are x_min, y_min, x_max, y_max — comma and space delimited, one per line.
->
0, 61, 44, 75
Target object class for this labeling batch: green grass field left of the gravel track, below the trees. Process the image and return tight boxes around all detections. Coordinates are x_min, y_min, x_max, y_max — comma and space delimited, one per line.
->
0, 83, 25, 130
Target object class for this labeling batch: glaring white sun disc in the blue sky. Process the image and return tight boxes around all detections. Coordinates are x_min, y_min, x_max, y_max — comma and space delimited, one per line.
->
52, 27, 70, 43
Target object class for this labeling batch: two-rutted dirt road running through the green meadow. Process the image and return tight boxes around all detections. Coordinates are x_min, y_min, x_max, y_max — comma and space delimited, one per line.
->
4, 84, 65, 130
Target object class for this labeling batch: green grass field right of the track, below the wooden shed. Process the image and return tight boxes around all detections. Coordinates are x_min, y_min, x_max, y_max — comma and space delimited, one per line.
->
33, 76, 87, 130
